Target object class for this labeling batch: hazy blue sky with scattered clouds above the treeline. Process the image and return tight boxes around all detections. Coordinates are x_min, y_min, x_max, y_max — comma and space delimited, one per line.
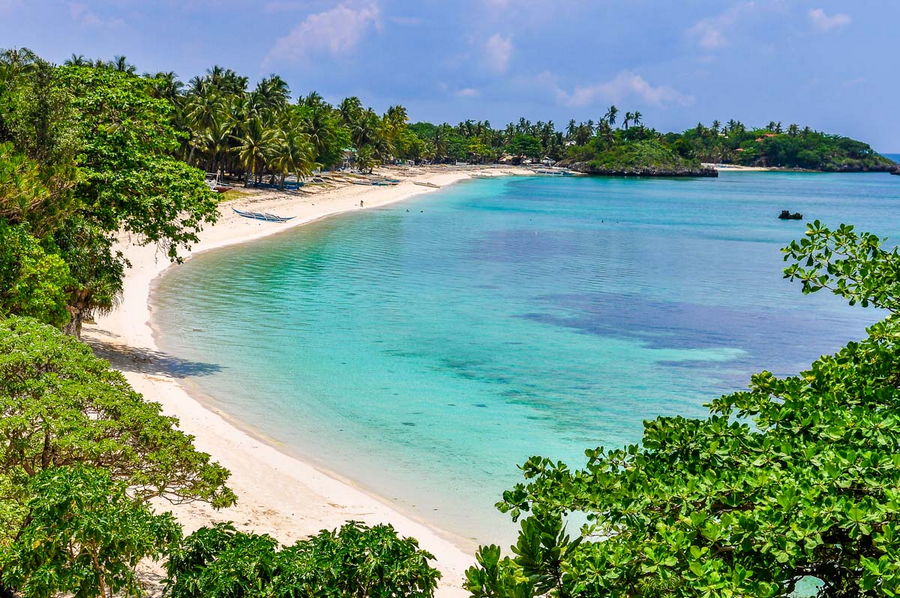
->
0, 0, 900, 153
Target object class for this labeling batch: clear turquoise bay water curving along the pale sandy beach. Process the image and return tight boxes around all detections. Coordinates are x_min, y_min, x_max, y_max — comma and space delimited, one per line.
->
154, 173, 900, 541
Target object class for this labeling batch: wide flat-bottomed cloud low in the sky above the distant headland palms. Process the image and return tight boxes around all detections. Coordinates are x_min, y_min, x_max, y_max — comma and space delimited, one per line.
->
556, 71, 694, 108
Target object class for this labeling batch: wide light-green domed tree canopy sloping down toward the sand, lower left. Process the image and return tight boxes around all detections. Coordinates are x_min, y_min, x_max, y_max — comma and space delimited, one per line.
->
0, 318, 235, 534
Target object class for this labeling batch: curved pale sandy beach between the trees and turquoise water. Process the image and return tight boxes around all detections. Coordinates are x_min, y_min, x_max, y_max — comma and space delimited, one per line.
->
83, 167, 531, 597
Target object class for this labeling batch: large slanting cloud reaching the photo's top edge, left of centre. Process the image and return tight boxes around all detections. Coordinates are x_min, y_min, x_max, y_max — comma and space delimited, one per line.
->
265, 0, 380, 63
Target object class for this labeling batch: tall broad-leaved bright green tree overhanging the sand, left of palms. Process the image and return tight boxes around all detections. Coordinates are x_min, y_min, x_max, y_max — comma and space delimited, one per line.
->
60, 67, 217, 259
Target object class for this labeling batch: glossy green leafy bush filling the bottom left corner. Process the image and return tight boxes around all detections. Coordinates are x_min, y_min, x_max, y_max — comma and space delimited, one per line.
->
0, 466, 181, 598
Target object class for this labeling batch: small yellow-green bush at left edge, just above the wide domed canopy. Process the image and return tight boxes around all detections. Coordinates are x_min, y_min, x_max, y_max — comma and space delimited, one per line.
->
0, 219, 72, 326
